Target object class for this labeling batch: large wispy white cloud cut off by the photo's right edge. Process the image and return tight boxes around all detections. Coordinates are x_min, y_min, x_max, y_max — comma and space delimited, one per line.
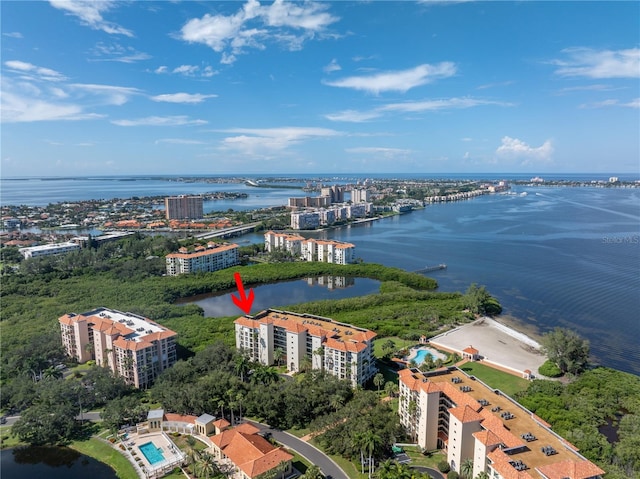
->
551, 48, 640, 78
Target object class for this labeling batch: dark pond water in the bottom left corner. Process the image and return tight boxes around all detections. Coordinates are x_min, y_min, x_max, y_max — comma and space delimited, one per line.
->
0, 447, 117, 479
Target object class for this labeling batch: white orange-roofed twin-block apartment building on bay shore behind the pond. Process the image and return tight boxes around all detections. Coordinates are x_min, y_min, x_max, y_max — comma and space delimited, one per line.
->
264, 231, 355, 264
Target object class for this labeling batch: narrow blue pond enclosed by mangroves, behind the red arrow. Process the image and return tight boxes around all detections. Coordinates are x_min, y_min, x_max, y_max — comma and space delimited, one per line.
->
178, 276, 380, 317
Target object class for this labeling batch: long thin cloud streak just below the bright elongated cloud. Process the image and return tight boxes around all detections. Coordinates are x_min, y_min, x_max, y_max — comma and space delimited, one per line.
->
325, 97, 513, 123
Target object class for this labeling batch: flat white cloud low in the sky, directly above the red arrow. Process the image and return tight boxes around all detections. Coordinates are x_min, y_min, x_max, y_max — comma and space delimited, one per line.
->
221, 127, 342, 155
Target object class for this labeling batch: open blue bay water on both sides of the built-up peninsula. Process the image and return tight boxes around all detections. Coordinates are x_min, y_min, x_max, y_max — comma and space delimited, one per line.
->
2, 176, 640, 375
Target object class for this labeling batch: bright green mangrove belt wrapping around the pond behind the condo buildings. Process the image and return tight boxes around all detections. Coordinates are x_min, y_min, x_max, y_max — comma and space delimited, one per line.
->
0, 237, 482, 380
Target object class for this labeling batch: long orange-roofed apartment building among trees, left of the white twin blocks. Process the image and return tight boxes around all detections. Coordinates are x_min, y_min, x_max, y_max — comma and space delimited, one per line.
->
165, 242, 240, 276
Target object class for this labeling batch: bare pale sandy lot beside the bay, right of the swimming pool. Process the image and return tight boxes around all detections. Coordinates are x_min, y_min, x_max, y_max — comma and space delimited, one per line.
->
429, 317, 546, 376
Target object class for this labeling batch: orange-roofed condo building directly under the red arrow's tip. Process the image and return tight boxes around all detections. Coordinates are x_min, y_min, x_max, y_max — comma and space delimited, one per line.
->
235, 309, 377, 387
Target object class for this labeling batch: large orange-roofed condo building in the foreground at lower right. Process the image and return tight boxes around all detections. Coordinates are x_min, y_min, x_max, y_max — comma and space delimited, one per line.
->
398, 367, 604, 479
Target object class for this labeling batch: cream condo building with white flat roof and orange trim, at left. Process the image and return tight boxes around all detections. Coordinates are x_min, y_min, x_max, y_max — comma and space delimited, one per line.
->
58, 308, 177, 388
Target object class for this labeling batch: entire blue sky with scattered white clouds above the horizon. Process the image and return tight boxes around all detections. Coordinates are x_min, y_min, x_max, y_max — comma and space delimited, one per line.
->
0, 0, 640, 177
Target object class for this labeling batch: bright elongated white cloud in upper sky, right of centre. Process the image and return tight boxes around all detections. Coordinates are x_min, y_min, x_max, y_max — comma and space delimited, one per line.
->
324, 62, 456, 95
